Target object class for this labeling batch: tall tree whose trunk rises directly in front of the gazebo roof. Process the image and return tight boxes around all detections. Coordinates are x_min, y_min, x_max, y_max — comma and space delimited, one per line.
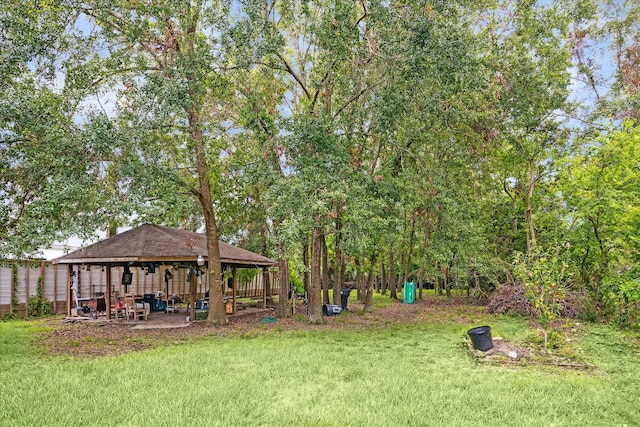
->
50, 0, 278, 323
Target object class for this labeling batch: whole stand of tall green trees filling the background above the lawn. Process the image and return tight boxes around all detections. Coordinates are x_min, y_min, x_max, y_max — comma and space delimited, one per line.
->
0, 0, 640, 325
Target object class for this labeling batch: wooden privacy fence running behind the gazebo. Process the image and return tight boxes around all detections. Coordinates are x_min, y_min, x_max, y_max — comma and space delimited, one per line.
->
0, 260, 278, 317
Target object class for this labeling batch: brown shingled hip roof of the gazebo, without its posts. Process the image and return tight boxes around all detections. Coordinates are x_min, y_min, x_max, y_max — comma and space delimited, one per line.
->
53, 224, 276, 267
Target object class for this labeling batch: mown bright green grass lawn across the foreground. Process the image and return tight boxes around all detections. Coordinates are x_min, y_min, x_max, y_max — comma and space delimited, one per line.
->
0, 306, 640, 426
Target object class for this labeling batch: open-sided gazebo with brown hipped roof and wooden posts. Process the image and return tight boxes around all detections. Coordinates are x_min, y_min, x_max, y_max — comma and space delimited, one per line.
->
53, 224, 276, 318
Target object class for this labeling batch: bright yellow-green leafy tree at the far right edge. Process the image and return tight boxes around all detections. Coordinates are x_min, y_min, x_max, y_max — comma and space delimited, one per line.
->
560, 122, 640, 325
